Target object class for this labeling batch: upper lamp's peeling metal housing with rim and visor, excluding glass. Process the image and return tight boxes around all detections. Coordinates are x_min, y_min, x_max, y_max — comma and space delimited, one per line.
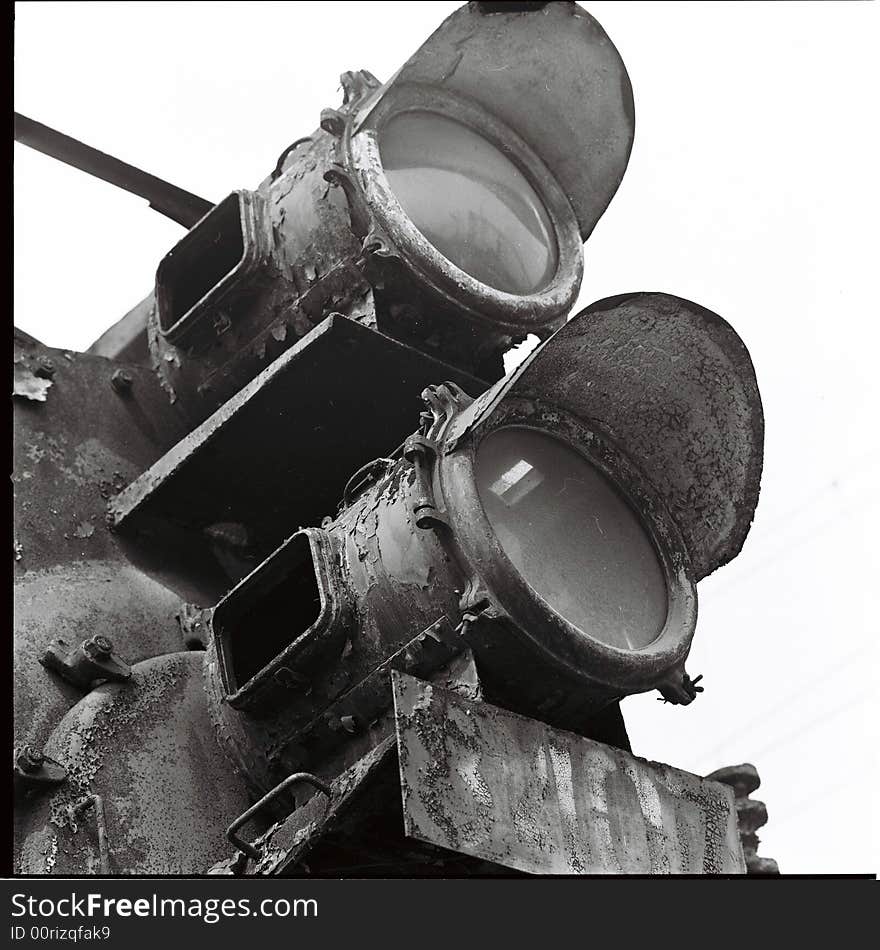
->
144, 3, 634, 421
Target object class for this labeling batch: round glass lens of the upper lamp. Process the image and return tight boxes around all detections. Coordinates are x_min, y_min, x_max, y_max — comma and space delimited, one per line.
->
379, 112, 557, 295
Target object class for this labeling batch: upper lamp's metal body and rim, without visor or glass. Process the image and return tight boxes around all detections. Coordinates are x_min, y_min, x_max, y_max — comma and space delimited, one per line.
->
149, 82, 583, 416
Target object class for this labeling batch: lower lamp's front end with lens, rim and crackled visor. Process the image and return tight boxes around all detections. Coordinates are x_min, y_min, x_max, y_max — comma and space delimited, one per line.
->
420, 294, 763, 719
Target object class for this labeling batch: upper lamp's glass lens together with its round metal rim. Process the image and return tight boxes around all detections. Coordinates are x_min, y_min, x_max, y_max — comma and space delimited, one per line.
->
348, 85, 583, 336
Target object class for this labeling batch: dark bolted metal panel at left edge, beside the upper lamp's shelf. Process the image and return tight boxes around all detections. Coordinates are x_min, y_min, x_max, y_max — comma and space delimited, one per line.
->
12, 335, 186, 576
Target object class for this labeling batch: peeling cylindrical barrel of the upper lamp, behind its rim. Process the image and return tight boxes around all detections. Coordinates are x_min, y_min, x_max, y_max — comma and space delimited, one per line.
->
147, 105, 375, 423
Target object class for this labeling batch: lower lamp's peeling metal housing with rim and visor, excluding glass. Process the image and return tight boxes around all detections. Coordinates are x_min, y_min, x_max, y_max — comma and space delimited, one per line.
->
207, 294, 763, 790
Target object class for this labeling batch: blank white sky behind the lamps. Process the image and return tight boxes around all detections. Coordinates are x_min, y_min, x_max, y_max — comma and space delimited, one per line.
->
15, 2, 880, 872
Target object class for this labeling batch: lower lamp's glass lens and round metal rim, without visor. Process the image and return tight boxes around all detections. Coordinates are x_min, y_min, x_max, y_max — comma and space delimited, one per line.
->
422, 395, 697, 728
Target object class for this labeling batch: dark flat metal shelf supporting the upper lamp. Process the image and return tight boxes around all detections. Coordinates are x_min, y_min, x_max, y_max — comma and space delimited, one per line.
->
111, 316, 485, 579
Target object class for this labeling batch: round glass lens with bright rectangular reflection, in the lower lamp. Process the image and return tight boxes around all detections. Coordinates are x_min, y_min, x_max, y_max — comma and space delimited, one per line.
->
476, 426, 667, 650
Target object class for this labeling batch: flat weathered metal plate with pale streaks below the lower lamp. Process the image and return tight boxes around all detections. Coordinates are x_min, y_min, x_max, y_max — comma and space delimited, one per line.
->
392, 672, 746, 874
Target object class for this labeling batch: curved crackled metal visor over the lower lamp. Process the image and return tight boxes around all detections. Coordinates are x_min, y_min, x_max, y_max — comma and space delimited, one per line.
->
447, 293, 764, 580
